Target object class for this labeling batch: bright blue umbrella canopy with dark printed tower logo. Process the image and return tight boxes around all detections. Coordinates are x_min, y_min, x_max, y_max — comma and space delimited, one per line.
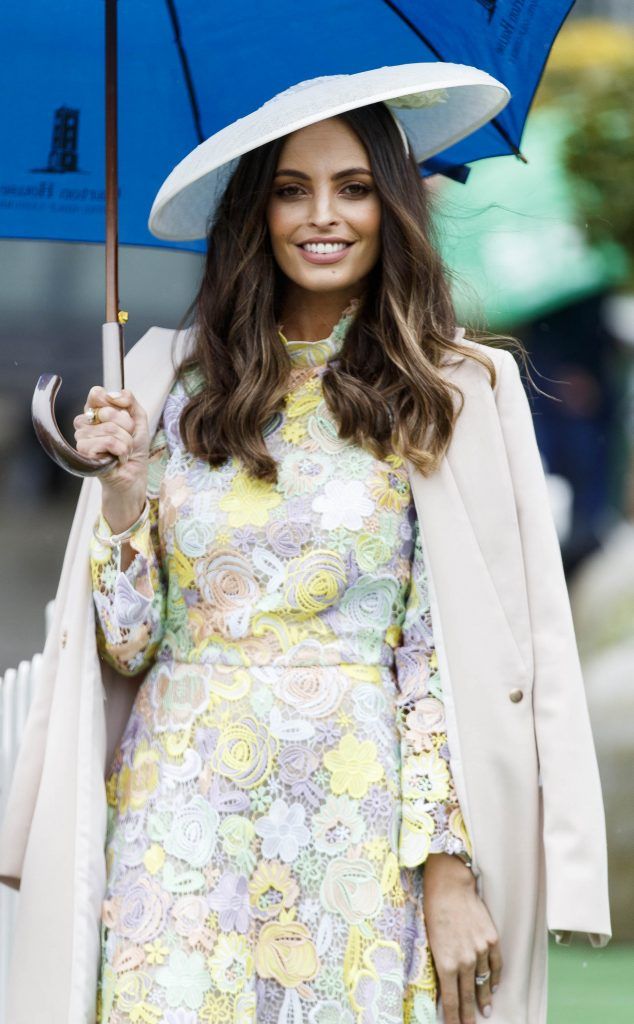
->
0, 0, 572, 250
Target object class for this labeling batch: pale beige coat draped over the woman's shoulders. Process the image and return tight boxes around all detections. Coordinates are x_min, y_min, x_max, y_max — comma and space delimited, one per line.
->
0, 328, 611, 1024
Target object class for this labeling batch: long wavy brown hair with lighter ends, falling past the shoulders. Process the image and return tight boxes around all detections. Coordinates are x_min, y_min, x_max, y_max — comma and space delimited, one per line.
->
179, 103, 521, 482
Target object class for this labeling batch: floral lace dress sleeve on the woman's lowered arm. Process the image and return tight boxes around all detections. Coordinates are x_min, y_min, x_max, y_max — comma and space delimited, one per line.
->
394, 520, 471, 867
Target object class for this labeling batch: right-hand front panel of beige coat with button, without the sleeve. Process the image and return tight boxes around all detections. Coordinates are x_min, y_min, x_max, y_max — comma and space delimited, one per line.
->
410, 355, 546, 1024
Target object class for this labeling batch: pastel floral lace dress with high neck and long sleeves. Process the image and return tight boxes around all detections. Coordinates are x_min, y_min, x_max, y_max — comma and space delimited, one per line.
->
90, 312, 471, 1024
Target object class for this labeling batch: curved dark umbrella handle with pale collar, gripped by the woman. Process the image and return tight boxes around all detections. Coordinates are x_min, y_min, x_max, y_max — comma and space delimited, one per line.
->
31, 323, 124, 476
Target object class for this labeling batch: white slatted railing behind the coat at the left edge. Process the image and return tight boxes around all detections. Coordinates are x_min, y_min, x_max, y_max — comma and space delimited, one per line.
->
0, 601, 53, 1024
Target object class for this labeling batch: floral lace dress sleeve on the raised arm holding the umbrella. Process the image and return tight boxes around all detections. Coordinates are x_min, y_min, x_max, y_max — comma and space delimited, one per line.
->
90, 422, 169, 676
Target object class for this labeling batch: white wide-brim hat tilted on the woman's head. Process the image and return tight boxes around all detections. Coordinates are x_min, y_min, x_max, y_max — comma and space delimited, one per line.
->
149, 60, 511, 242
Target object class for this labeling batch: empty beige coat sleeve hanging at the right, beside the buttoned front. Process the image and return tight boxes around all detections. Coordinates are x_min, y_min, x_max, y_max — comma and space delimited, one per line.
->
496, 352, 611, 946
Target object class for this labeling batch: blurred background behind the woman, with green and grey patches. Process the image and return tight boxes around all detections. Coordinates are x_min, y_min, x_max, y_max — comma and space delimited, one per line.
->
0, 0, 634, 1024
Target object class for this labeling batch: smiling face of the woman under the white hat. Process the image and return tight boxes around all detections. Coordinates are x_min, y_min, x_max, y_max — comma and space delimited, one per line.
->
266, 118, 381, 292
